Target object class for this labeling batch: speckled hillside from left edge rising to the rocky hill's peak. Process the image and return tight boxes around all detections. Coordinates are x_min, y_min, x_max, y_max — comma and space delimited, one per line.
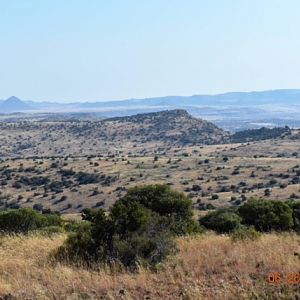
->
0, 110, 229, 157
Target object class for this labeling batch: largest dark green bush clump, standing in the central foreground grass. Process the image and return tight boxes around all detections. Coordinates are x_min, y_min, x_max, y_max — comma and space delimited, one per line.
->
56, 185, 200, 269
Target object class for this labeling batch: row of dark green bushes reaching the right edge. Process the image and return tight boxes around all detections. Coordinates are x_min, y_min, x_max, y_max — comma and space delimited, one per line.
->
199, 199, 300, 233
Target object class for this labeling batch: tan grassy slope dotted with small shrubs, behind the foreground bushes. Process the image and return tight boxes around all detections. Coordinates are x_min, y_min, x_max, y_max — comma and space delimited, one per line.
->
0, 141, 300, 214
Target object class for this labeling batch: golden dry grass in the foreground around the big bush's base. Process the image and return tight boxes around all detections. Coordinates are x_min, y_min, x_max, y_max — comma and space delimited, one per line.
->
0, 234, 300, 299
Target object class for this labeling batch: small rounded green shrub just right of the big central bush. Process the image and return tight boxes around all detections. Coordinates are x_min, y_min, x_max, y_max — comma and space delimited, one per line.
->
199, 209, 241, 233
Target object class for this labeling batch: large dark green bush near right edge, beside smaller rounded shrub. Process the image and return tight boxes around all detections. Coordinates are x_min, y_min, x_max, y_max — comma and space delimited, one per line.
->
238, 199, 293, 231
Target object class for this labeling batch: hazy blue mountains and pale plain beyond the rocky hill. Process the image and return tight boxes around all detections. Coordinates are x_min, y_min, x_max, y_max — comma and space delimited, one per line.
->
0, 89, 300, 130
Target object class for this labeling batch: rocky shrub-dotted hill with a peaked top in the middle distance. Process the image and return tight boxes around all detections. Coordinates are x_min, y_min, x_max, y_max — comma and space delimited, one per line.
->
103, 109, 229, 145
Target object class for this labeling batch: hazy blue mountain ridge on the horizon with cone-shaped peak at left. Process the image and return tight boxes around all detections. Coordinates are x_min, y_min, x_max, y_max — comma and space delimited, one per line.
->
0, 89, 300, 113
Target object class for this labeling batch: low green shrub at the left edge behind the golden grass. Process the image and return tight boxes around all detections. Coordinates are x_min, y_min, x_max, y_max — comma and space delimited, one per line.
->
0, 208, 62, 233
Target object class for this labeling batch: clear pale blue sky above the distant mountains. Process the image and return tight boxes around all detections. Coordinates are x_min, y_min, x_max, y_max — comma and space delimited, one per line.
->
0, 0, 300, 102
